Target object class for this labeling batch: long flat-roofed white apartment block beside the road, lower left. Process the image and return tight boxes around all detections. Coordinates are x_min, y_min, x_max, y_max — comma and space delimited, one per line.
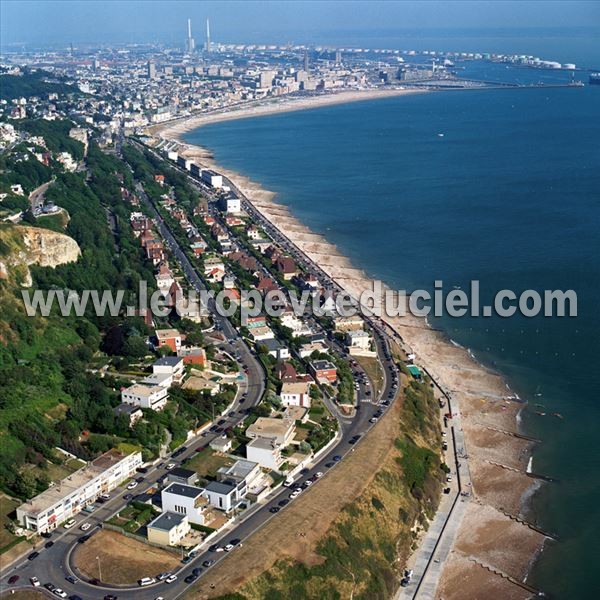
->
17, 450, 142, 533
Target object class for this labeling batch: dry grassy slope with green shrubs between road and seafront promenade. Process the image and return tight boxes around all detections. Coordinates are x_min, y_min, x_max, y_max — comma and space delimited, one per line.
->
217, 382, 442, 600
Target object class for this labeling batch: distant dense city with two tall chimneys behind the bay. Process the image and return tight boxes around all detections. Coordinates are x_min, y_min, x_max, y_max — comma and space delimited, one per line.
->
0, 19, 596, 138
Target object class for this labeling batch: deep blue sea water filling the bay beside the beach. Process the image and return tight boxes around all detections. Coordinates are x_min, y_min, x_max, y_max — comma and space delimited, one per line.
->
187, 74, 600, 598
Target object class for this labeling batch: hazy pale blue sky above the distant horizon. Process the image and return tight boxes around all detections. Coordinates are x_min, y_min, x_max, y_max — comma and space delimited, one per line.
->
0, 0, 600, 45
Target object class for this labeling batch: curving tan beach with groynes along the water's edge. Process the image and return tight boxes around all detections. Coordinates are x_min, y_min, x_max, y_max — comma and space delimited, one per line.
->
150, 90, 548, 599
